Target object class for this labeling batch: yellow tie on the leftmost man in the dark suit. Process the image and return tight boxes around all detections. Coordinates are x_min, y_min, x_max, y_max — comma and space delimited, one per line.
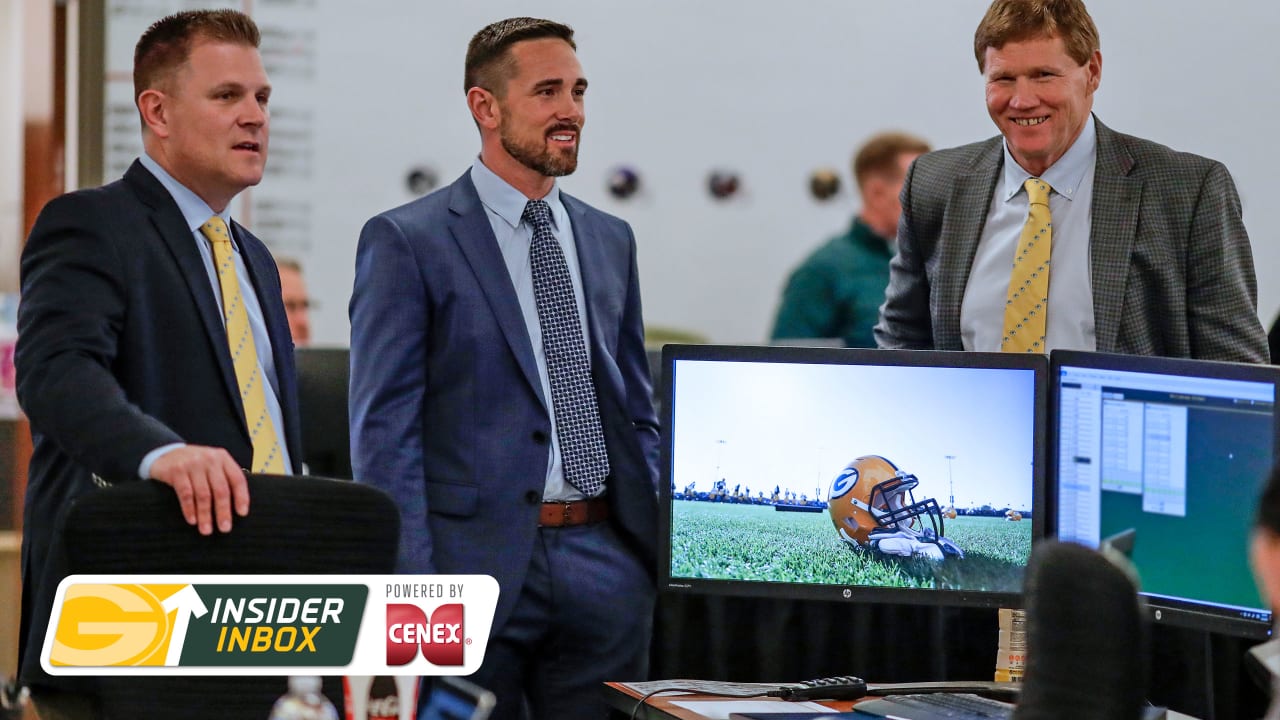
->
200, 215, 285, 475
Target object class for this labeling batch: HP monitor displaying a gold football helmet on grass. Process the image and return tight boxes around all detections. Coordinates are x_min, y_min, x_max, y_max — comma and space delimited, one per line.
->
659, 345, 1048, 607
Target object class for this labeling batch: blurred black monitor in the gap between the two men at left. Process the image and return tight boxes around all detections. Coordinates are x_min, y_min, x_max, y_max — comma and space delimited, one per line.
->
293, 347, 352, 479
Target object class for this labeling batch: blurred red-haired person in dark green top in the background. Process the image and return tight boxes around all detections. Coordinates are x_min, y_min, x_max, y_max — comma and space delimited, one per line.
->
772, 132, 929, 347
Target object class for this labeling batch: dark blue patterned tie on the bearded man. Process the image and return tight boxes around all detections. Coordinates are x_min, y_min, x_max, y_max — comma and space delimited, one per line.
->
521, 200, 609, 497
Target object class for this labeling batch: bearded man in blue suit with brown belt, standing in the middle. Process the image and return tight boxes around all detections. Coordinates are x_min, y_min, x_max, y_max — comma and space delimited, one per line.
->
351, 18, 658, 720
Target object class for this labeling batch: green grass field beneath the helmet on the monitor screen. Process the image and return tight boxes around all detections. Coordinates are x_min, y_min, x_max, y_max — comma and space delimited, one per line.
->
671, 501, 1032, 592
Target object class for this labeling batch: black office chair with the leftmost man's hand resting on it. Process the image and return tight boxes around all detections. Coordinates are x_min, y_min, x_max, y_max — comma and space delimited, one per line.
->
61, 475, 399, 720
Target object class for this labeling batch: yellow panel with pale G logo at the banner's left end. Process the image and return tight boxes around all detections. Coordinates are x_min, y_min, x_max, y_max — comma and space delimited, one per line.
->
49, 584, 198, 667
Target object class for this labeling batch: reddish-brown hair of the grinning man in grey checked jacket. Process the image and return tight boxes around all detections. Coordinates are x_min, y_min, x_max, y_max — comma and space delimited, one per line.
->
973, 0, 1101, 73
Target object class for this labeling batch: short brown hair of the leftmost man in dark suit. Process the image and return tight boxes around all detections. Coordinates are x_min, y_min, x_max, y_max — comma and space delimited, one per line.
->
133, 10, 261, 102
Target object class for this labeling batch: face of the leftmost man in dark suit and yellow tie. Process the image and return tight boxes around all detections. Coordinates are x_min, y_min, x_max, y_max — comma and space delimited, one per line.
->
138, 40, 271, 211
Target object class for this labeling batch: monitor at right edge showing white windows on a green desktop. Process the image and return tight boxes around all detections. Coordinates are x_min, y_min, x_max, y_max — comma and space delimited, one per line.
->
1050, 351, 1280, 638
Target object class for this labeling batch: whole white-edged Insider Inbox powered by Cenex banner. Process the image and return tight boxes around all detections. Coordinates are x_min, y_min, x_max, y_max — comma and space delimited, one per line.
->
40, 574, 498, 675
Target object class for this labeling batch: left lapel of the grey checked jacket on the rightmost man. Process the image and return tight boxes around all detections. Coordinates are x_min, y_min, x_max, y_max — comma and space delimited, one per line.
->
933, 137, 1004, 348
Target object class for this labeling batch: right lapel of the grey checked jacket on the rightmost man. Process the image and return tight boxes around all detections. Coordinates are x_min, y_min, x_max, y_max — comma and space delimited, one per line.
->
1089, 118, 1142, 350
